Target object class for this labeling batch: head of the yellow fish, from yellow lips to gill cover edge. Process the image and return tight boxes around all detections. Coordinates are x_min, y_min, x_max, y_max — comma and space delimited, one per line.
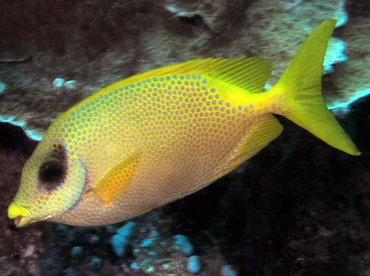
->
8, 130, 86, 227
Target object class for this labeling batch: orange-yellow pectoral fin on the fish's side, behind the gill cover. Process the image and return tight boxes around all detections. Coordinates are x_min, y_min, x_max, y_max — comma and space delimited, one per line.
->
92, 151, 143, 206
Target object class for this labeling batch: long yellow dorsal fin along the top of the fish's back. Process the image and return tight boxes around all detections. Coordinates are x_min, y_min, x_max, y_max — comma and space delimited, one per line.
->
106, 57, 272, 93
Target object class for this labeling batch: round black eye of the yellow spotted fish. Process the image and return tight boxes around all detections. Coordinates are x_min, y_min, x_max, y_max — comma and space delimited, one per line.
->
39, 160, 64, 186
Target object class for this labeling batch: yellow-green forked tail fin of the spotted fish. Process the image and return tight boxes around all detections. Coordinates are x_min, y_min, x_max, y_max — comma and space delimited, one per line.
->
270, 19, 360, 155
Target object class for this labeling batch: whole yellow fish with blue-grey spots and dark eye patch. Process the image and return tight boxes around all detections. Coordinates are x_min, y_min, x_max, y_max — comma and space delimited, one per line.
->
8, 19, 360, 227
